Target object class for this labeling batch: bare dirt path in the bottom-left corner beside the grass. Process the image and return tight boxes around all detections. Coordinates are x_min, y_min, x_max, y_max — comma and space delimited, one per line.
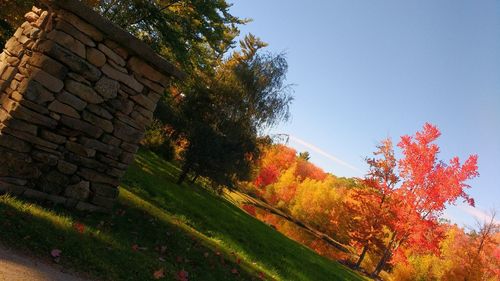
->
0, 245, 89, 281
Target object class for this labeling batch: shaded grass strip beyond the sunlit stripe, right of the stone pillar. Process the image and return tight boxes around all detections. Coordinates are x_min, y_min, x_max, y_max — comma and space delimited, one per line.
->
123, 151, 364, 281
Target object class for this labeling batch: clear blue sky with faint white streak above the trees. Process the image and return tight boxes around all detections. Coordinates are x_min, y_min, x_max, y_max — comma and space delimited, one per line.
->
231, 0, 500, 225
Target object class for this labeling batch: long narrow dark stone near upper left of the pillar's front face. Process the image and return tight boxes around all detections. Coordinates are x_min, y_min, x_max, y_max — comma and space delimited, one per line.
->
36, 40, 101, 82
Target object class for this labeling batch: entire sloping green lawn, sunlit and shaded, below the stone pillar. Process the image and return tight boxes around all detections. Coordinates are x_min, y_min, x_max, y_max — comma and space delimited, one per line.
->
0, 151, 365, 281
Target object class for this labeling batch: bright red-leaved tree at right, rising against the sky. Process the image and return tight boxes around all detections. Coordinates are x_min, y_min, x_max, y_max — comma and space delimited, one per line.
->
372, 123, 478, 276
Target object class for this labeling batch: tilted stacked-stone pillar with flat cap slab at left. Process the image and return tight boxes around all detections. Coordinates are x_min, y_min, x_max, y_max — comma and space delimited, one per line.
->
0, 0, 183, 211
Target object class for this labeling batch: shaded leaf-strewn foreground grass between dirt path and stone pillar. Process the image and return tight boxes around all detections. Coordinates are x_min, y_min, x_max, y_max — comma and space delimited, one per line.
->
0, 190, 255, 281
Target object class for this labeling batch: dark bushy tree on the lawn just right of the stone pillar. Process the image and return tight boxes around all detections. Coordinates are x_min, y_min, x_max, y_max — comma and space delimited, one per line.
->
176, 35, 292, 186
